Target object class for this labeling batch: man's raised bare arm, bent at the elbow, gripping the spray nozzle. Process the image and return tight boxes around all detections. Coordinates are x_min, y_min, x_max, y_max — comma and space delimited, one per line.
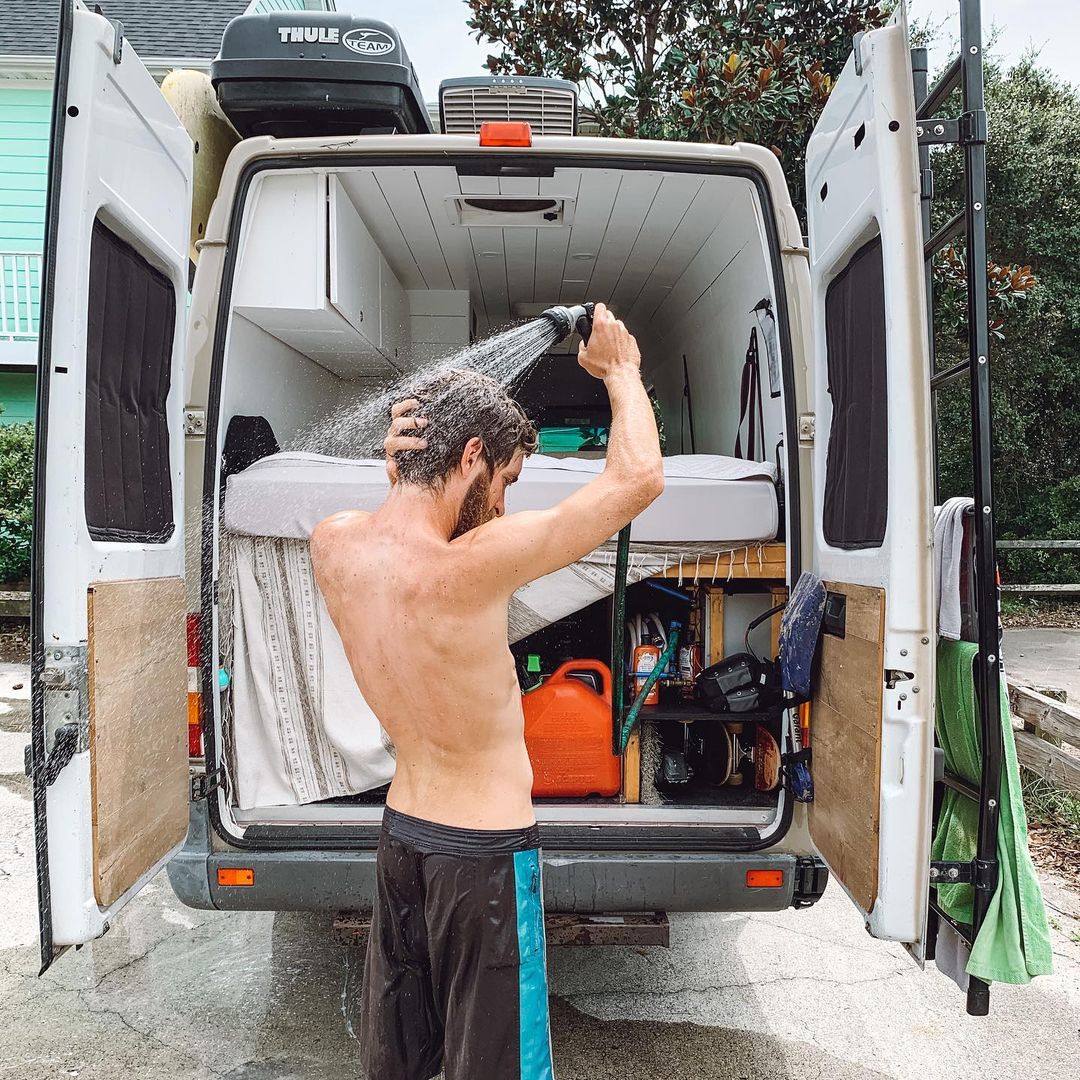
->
464, 303, 664, 589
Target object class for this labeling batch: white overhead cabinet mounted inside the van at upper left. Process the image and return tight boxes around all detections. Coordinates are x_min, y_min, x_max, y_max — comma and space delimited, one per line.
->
235, 173, 409, 379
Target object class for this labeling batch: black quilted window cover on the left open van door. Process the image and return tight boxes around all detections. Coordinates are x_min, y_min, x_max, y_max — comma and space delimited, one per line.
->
85, 221, 176, 543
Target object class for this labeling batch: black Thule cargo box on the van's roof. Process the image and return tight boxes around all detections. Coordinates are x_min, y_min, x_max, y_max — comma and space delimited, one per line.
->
211, 11, 432, 138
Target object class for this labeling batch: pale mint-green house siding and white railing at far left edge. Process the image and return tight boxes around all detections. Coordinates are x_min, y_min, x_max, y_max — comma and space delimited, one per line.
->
0, 83, 52, 336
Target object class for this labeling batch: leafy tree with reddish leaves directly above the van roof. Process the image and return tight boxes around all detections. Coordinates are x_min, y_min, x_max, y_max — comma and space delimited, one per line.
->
468, 0, 892, 204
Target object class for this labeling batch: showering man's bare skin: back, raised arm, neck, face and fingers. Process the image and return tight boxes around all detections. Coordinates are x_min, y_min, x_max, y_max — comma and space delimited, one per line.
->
311, 305, 663, 829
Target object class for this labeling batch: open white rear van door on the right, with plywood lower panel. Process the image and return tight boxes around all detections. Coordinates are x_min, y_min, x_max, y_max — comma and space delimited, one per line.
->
807, 4, 934, 958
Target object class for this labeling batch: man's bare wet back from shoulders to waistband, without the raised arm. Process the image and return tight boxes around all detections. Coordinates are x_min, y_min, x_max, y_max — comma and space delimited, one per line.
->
311, 458, 534, 828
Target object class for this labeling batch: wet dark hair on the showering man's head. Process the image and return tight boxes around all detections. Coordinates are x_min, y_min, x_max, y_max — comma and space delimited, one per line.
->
394, 368, 538, 488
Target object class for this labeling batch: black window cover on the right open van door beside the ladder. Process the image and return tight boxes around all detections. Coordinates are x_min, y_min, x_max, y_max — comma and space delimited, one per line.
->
822, 238, 889, 549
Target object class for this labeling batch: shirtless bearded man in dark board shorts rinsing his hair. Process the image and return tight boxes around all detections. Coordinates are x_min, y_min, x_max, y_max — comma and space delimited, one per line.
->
311, 305, 663, 1080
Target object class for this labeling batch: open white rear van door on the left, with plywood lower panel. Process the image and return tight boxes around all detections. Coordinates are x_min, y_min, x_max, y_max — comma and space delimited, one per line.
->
28, 0, 192, 970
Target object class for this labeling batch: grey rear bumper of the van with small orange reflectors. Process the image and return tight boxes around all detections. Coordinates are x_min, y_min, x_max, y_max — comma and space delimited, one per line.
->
168, 804, 827, 915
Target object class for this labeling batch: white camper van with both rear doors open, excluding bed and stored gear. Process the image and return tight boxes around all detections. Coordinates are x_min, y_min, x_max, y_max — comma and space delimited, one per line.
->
29, 0, 1002, 1010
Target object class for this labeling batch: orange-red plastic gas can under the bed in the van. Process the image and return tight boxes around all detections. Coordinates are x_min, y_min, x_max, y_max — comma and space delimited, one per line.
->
522, 660, 622, 798
